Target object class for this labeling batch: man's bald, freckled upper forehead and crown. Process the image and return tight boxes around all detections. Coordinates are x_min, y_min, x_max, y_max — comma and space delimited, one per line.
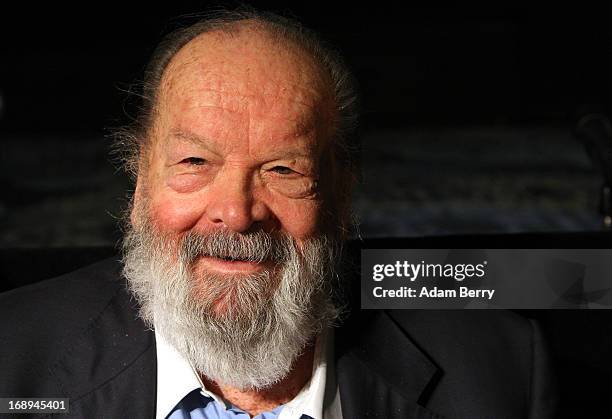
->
158, 20, 334, 111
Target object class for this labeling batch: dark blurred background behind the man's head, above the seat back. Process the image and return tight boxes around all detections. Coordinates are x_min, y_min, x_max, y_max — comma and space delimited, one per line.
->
0, 2, 612, 247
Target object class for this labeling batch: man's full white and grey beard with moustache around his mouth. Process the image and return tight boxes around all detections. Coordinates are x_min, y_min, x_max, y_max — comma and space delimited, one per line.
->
123, 218, 339, 390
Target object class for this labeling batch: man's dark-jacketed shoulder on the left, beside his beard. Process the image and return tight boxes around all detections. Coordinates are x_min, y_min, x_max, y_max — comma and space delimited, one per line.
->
0, 258, 155, 404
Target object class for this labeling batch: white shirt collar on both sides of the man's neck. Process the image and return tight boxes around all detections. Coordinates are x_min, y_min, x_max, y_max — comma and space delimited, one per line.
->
155, 329, 333, 419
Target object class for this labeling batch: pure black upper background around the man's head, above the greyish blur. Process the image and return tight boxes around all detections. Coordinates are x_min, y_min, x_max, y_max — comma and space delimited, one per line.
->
0, 1, 612, 134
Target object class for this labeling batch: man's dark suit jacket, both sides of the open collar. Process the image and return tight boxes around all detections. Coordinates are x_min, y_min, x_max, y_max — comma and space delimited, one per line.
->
0, 259, 554, 419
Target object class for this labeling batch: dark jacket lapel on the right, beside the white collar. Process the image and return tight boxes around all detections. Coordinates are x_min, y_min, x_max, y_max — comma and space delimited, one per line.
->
336, 311, 442, 419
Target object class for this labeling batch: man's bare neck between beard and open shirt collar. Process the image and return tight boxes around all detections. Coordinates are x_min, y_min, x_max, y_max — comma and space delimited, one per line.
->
202, 345, 314, 417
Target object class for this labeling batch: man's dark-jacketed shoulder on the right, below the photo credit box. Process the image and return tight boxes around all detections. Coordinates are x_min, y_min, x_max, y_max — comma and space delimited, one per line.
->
337, 310, 555, 417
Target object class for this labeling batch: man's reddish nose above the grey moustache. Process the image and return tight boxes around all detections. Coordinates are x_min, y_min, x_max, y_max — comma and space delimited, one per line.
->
206, 170, 272, 233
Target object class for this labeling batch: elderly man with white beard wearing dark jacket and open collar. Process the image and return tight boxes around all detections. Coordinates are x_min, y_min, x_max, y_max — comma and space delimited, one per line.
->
0, 7, 552, 419
